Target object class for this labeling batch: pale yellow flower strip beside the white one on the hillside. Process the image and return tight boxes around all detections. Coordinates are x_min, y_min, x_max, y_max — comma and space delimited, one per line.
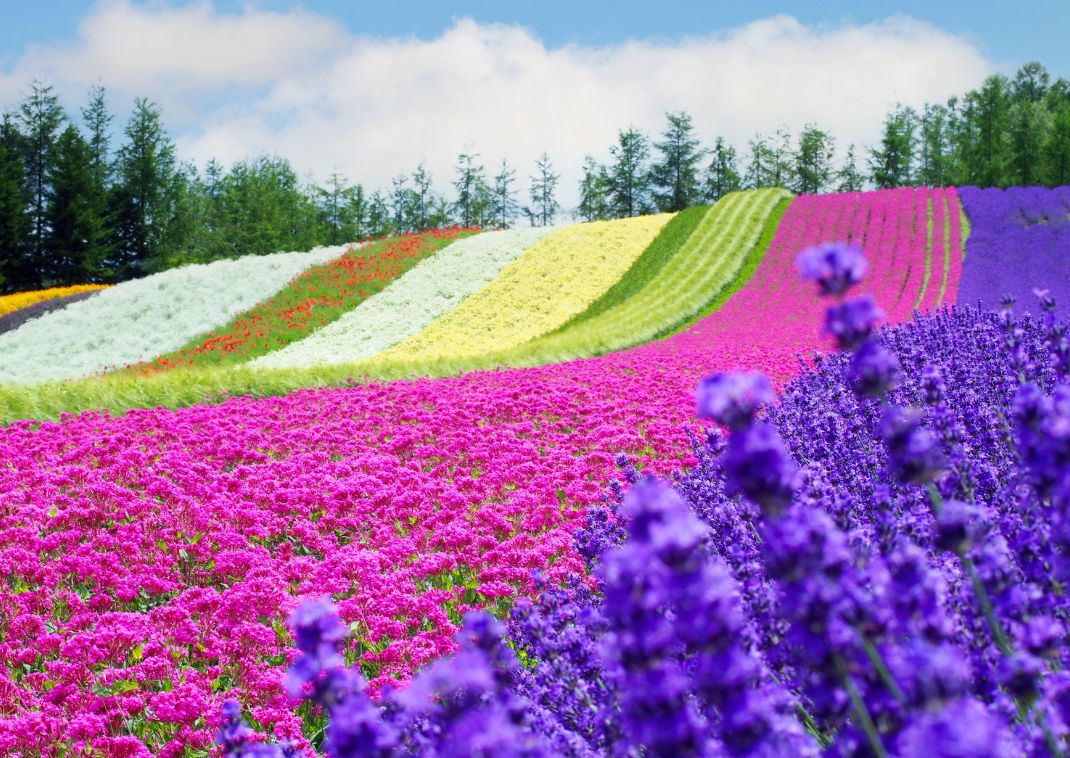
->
380, 213, 672, 362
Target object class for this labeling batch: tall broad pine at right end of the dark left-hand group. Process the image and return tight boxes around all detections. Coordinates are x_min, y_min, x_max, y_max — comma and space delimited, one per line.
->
109, 97, 175, 279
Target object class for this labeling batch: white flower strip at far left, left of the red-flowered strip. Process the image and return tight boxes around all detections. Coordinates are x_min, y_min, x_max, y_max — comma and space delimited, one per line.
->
0, 245, 349, 384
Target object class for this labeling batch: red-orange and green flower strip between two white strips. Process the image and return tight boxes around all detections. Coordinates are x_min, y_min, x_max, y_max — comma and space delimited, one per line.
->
133, 228, 475, 375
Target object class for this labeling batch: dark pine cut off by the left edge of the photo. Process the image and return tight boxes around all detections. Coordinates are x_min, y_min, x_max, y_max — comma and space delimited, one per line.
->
0, 117, 33, 291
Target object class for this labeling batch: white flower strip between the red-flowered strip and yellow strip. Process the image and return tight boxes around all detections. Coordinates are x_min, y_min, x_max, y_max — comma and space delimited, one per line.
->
250, 227, 553, 368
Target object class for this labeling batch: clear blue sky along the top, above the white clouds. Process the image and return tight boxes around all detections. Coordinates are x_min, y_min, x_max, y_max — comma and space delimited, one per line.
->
0, 0, 1070, 76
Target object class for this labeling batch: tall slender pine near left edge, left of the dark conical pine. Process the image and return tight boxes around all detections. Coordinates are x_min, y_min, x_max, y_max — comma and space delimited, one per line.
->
19, 81, 66, 283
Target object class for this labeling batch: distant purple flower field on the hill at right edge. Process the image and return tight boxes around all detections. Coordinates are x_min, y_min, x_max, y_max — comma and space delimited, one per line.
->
959, 186, 1070, 318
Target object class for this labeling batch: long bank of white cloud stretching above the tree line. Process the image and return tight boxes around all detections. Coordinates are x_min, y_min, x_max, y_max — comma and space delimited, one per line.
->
0, 2, 995, 209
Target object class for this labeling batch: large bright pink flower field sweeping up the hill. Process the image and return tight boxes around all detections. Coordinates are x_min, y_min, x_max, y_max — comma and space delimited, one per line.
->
0, 190, 962, 756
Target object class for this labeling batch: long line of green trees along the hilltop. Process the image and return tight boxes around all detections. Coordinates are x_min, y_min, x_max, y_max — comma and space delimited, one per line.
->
0, 63, 1070, 291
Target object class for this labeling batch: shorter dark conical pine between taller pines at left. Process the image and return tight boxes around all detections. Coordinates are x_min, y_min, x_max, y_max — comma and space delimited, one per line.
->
46, 126, 108, 286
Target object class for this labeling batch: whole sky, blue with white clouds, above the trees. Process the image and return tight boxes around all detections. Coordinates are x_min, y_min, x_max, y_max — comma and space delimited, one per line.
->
0, 0, 1052, 203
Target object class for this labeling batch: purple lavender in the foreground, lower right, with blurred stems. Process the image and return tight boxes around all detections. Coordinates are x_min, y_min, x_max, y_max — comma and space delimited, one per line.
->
217, 246, 1070, 758
